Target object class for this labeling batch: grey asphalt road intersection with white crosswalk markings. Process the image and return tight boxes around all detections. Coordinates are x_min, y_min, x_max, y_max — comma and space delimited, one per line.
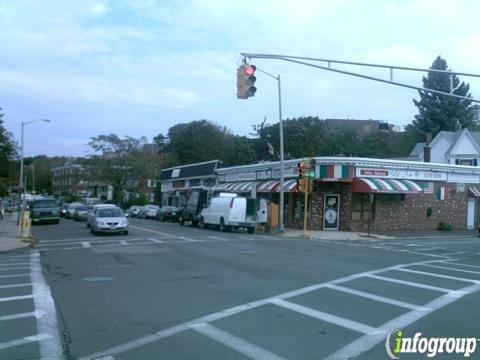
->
0, 219, 480, 359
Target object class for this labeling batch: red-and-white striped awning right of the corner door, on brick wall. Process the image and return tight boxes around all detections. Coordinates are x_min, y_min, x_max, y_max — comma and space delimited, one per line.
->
352, 178, 422, 194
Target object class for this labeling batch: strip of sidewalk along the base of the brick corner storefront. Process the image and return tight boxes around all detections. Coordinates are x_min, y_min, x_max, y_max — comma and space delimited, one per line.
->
283, 229, 477, 241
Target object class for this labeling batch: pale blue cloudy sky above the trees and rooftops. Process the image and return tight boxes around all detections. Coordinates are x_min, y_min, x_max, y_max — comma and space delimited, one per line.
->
0, 0, 480, 156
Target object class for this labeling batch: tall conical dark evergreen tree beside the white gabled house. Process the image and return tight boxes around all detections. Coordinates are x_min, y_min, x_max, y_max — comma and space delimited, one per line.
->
407, 56, 475, 141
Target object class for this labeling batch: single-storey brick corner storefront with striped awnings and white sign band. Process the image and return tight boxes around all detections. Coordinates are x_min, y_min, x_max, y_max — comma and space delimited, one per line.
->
212, 157, 480, 231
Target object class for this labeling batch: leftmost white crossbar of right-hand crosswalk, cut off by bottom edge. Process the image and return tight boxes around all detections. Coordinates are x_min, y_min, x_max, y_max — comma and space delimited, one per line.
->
190, 323, 284, 360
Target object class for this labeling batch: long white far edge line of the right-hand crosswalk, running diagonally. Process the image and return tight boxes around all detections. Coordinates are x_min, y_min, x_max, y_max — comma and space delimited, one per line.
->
80, 260, 450, 360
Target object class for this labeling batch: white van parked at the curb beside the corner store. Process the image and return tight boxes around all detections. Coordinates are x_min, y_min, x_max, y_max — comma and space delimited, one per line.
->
199, 196, 267, 234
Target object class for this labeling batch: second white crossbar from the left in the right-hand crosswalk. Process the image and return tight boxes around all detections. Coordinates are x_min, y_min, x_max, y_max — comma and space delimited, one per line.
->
270, 299, 384, 334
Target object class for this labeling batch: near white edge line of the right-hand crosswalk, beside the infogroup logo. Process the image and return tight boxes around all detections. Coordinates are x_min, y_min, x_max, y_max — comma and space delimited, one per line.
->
325, 284, 480, 360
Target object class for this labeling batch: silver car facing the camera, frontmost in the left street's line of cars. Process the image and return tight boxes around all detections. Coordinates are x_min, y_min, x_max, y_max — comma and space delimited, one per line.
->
90, 206, 128, 235
